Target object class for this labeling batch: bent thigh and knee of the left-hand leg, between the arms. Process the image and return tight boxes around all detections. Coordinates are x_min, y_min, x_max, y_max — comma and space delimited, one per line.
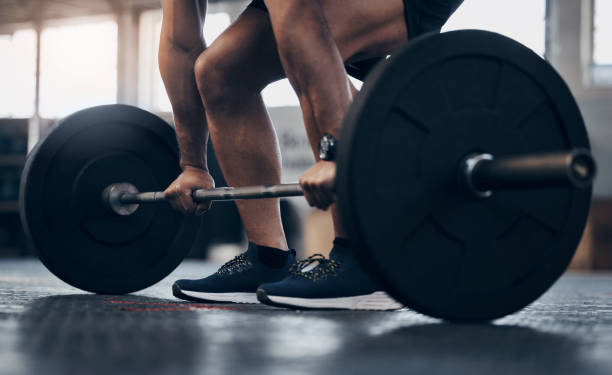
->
204, 7, 285, 89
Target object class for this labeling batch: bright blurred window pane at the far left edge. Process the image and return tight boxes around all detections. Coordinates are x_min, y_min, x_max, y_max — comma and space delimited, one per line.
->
0, 29, 36, 118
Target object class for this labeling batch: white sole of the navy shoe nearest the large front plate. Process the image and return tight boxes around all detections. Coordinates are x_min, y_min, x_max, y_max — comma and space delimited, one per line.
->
257, 289, 404, 311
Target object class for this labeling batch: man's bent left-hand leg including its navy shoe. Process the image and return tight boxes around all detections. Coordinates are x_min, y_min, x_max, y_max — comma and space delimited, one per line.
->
173, 7, 304, 303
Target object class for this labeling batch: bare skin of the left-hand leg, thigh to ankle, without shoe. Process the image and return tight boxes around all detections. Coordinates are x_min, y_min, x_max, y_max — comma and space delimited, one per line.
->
195, 8, 288, 250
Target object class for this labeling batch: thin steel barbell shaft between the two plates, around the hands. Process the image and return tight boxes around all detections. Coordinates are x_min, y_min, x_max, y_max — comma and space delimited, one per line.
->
119, 184, 304, 204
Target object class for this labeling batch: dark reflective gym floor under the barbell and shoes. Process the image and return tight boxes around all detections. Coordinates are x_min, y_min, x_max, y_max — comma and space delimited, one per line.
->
0, 260, 612, 375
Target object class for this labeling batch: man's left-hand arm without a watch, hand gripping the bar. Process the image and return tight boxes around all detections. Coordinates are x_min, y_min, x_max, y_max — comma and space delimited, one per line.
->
159, 0, 214, 214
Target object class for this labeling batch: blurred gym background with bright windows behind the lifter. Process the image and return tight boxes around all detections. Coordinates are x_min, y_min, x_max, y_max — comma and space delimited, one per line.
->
0, 0, 612, 270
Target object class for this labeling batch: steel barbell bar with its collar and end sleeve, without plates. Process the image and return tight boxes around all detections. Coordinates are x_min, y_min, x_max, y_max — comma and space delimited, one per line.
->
102, 149, 596, 216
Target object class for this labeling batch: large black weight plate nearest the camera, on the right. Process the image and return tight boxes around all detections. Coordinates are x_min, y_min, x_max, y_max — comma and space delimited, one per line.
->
337, 30, 591, 321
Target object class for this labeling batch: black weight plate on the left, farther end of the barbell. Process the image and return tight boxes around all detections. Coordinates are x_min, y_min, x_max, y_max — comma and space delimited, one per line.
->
20, 105, 199, 294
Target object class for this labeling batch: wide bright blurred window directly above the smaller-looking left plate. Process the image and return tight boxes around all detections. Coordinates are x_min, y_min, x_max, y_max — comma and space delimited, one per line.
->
40, 21, 117, 118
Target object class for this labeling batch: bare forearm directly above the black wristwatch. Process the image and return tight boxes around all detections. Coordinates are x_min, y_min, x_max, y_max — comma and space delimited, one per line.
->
275, 2, 352, 137
